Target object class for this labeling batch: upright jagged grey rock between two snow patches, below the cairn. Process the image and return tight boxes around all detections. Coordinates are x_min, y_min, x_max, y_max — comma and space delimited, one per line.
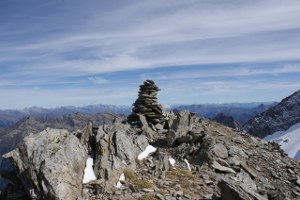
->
94, 123, 149, 191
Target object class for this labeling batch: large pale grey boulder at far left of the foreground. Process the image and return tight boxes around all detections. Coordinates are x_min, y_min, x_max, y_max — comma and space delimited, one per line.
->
5, 128, 87, 200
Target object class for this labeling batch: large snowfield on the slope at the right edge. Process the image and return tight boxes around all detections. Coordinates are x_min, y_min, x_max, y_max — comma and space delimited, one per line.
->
264, 123, 300, 160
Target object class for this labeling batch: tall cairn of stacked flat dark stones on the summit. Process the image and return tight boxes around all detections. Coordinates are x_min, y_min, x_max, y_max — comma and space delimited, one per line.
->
128, 80, 164, 125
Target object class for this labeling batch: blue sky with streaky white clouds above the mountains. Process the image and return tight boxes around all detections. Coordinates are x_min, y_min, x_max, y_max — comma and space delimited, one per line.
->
0, 0, 300, 109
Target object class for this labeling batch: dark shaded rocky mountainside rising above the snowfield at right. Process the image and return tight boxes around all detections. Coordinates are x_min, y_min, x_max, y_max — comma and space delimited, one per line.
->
243, 90, 300, 138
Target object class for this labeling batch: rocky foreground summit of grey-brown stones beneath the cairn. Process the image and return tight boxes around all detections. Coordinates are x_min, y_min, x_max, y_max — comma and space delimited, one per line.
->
3, 112, 300, 200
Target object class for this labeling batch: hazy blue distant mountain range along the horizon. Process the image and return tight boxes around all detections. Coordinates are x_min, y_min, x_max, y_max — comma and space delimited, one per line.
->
0, 102, 276, 129
